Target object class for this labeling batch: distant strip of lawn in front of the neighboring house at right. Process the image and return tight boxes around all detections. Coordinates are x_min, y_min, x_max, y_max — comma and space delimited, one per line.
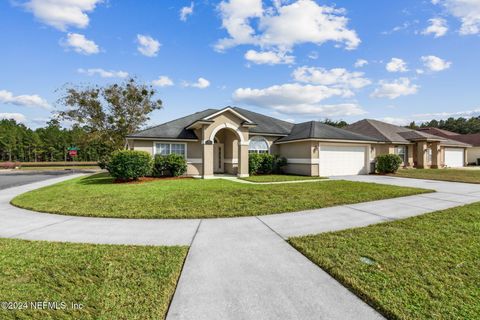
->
394, 169, 480, 183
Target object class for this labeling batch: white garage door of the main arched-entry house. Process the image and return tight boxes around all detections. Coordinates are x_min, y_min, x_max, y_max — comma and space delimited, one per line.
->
320, 146, 367, 177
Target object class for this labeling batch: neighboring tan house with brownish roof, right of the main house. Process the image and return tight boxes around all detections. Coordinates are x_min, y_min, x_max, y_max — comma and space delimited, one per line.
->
345, 119, 470, 168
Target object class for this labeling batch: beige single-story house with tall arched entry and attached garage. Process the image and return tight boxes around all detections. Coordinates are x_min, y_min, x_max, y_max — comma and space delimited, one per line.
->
127, 107, 379, 178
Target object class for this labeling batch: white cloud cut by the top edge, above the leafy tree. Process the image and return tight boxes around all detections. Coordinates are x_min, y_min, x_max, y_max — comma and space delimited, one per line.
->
24, 0, 103, 31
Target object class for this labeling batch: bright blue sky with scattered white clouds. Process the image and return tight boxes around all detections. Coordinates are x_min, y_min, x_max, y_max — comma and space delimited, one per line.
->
0, 0, 480, 127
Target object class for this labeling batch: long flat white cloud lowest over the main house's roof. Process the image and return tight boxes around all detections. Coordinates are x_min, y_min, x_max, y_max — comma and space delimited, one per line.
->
233, 83, 365, 117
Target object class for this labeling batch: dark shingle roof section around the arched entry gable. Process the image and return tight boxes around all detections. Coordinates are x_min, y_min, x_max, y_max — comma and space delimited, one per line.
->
128, 107, 294, 140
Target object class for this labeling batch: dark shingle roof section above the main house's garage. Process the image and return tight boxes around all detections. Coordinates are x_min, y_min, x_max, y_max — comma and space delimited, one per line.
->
277, 121, 378, 142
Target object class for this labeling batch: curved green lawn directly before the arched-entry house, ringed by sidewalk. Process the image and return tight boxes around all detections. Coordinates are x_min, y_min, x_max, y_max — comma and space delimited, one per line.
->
12, 174, 429, 218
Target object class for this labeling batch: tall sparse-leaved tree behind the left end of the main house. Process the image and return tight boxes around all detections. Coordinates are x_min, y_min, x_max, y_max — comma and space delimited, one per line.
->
57, 78, 162, 150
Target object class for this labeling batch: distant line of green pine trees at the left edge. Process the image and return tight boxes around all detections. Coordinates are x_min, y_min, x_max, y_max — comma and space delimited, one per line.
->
0, 119, 112, 162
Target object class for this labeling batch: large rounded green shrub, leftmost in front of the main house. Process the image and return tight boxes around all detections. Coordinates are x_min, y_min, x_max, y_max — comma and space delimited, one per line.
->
107, 150, 153, 180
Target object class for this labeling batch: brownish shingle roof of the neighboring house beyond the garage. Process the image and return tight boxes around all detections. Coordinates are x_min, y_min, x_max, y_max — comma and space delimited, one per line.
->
345, 119, 468, 147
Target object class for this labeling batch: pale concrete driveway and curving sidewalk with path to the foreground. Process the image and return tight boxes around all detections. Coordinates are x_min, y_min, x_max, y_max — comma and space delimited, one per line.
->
0, 175, 480, 320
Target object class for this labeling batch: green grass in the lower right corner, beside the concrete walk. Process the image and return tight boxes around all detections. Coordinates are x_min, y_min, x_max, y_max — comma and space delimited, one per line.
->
290, 203, 480, 319
